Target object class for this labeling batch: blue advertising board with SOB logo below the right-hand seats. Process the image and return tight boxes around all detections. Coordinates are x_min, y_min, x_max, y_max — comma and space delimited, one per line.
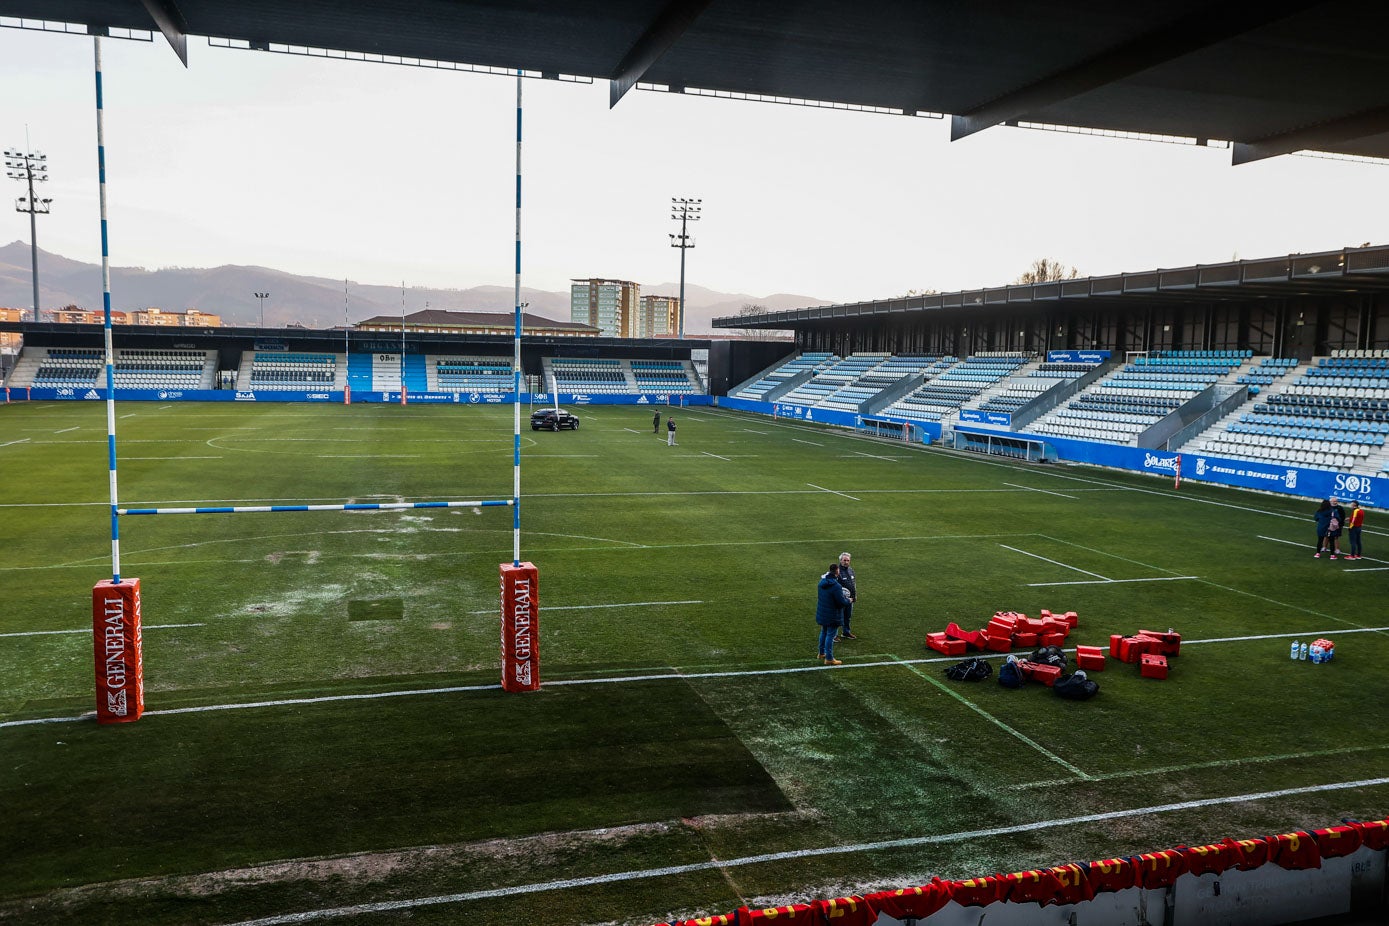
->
956, 428, 1389, 508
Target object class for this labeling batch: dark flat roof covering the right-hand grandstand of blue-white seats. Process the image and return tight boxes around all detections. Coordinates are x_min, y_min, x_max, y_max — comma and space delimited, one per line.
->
714, 246, 1389, 329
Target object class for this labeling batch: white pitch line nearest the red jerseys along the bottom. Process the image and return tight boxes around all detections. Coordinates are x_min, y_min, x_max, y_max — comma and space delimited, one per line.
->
222, 777, 1389, 926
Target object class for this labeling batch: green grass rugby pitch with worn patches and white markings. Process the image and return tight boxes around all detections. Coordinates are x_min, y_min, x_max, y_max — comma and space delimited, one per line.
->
0, 403, 1389, 926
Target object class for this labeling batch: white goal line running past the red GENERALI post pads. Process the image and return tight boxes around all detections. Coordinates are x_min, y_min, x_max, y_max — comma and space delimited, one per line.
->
10, 621, 1389, 729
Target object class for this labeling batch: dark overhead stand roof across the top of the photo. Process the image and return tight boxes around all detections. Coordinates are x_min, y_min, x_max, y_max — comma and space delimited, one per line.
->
8, 0, 1389, 162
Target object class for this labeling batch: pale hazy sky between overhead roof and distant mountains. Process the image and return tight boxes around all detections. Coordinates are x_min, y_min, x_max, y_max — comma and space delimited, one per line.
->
0, 28, 1389, 301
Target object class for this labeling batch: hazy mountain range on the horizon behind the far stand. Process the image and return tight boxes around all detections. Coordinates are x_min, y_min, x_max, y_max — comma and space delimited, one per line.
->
0, 242, 829, 335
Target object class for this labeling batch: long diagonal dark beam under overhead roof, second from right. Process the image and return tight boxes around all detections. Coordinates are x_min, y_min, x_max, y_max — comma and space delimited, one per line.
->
950, 0, 1317, 142
